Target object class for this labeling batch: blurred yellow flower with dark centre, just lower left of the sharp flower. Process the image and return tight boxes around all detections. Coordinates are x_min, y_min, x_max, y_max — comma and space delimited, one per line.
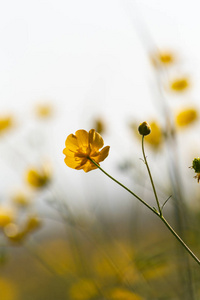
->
26, 166, 51, 188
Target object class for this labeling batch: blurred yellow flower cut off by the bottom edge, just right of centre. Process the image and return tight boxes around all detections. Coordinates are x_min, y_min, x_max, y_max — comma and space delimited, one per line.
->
108, 287, 143, 300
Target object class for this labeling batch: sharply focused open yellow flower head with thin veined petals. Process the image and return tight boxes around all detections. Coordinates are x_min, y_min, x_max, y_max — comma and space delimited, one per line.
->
63, 129, 110, 172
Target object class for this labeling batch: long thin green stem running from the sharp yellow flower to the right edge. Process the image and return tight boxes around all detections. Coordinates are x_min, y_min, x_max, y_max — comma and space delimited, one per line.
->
88, 157, 200, 265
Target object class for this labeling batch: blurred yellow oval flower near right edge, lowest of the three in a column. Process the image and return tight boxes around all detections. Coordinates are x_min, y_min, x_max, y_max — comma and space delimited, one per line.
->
176, 108, 198, 127
